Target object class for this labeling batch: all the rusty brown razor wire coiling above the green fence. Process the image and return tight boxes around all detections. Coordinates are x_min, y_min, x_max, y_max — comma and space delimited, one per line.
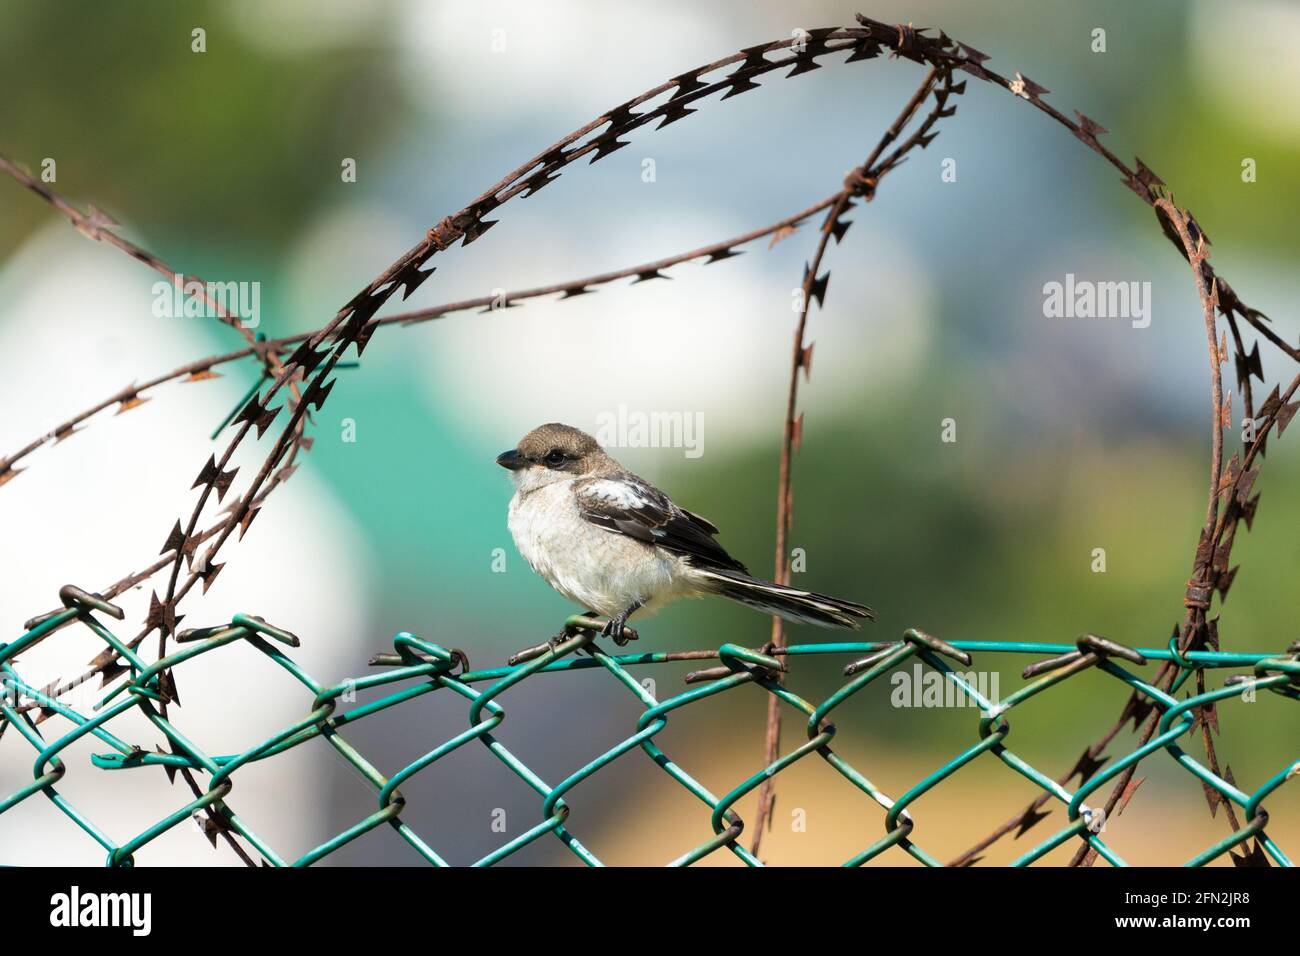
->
0, 14, 1300, 864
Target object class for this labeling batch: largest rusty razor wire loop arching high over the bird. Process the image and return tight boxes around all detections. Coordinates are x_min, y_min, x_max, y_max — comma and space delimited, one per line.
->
0, 14, 1300, 868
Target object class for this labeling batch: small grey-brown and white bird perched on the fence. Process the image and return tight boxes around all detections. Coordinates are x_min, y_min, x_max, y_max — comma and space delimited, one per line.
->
497, 423, 876, 644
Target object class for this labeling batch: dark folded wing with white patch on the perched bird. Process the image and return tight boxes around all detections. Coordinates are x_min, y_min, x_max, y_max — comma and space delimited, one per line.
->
573, 475, 748, 574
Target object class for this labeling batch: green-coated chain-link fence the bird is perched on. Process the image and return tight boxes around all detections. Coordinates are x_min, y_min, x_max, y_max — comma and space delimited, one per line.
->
0, 585, 1300, 866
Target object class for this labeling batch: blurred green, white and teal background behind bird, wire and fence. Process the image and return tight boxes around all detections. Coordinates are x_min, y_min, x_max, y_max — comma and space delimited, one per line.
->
0, 0, 1300, 865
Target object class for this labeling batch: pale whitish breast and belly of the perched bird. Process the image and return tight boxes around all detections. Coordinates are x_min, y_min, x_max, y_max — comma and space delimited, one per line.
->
508, 480, 689, 617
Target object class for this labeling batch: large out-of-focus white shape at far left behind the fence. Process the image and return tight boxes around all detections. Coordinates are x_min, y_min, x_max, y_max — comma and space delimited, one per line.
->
0, 221, 368, 865
